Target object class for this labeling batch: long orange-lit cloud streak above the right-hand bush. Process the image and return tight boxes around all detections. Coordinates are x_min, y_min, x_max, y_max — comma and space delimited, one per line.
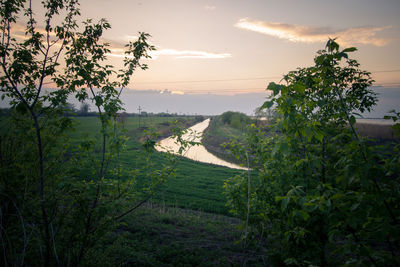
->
234, 18, 390, 46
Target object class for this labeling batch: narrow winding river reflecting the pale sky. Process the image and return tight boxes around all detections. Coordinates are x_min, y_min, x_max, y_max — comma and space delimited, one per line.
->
156, 119, 247, 170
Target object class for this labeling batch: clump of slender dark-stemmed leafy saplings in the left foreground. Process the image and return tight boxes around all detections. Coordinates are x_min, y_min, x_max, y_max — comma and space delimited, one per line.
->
0, 0, 189, 266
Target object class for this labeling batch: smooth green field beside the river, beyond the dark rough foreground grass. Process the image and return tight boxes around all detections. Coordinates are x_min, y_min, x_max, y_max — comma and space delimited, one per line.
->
72, 117, 241, 215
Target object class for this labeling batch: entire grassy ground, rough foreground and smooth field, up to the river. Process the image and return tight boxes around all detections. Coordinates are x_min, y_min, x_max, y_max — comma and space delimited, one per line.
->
69, 118, 264, 266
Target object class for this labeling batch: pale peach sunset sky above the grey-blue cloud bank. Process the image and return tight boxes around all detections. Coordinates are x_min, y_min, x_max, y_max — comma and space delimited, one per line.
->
27, 0, 400, 94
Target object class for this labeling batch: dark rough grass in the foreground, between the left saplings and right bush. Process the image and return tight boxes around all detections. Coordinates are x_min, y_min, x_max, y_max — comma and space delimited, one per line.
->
83, 203, 263, 266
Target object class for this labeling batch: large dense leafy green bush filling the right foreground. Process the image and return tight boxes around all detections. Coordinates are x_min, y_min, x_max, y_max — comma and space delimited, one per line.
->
225, 40, 400, 266
